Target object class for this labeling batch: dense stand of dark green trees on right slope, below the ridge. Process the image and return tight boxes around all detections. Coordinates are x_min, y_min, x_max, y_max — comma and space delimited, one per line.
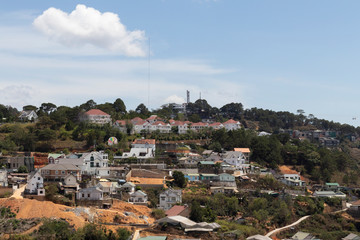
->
205, 129, 358, 184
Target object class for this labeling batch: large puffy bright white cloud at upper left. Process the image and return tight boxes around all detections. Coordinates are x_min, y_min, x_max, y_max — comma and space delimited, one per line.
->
33, 4, 146, 57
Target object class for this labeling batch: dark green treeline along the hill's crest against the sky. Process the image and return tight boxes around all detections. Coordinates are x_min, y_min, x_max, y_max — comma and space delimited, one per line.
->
0, 98, 360, 136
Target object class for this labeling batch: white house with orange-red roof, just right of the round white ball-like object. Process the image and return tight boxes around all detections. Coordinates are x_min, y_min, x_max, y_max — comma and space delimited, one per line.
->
122, 139, 156, 159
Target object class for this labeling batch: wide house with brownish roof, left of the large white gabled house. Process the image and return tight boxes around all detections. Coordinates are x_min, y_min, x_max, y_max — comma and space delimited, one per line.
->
40, 163, 81, 181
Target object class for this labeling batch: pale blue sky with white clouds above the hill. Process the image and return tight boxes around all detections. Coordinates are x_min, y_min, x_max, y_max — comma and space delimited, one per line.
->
0, 0, 360, 126
